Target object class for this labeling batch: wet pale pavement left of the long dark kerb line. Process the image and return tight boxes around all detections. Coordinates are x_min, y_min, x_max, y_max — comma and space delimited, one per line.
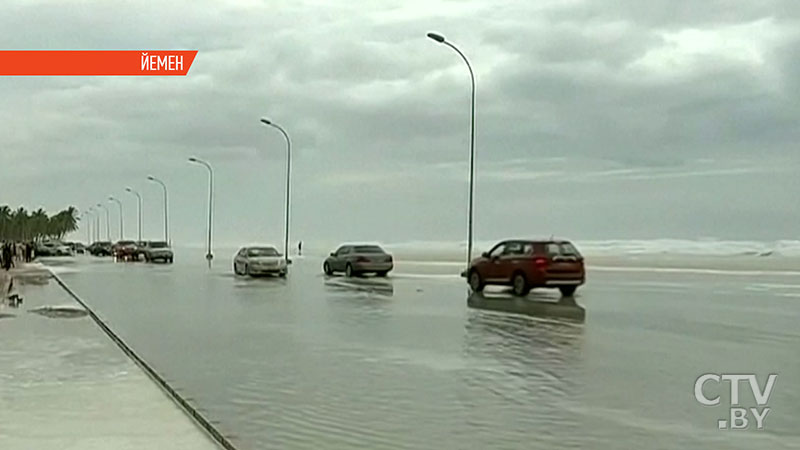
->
0, 269, 219, 450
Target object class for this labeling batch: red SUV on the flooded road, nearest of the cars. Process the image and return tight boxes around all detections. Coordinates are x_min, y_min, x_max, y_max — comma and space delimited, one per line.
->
466, 240, 586, 296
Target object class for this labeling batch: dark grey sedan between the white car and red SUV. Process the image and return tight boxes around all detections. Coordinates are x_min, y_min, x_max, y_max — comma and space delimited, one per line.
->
322, 244, 394, 277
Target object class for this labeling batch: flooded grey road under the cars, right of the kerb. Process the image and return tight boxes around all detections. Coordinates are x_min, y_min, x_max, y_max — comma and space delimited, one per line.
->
50, 252, 800, 450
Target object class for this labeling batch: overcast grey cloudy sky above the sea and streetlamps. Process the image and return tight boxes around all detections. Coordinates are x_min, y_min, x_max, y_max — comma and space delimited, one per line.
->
0, 0, 800, 250
